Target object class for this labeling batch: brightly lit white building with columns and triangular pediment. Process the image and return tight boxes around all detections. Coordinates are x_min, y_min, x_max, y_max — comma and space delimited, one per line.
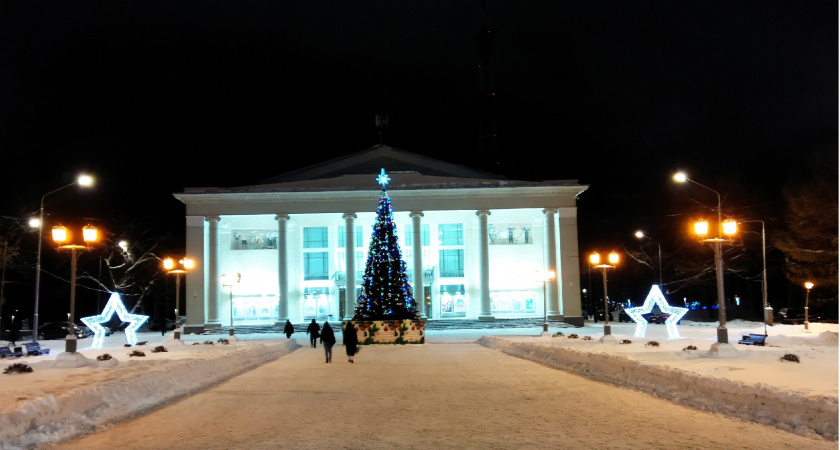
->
174, 145, 588, 333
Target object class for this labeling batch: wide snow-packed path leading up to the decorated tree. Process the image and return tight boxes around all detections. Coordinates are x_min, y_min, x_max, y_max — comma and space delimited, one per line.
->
53, 338, 837, 450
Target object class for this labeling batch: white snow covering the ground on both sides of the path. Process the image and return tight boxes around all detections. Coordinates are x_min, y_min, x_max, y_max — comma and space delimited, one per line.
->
0, 320, 838, 449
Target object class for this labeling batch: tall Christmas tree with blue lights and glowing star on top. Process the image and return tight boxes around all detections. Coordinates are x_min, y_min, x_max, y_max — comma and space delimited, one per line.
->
353, 169, 419, 321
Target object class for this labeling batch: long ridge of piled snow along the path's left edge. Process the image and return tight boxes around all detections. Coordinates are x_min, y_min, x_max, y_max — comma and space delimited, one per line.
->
0, 341, 300, 449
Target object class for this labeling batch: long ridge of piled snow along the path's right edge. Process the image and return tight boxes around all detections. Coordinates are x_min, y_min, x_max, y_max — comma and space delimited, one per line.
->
478, 336, 838, 440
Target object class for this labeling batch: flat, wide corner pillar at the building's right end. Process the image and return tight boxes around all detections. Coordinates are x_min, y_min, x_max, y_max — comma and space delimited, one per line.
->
557, 207, 583, 327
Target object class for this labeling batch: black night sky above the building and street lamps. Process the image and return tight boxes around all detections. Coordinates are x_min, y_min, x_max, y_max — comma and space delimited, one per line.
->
0, 0, 838, 314
